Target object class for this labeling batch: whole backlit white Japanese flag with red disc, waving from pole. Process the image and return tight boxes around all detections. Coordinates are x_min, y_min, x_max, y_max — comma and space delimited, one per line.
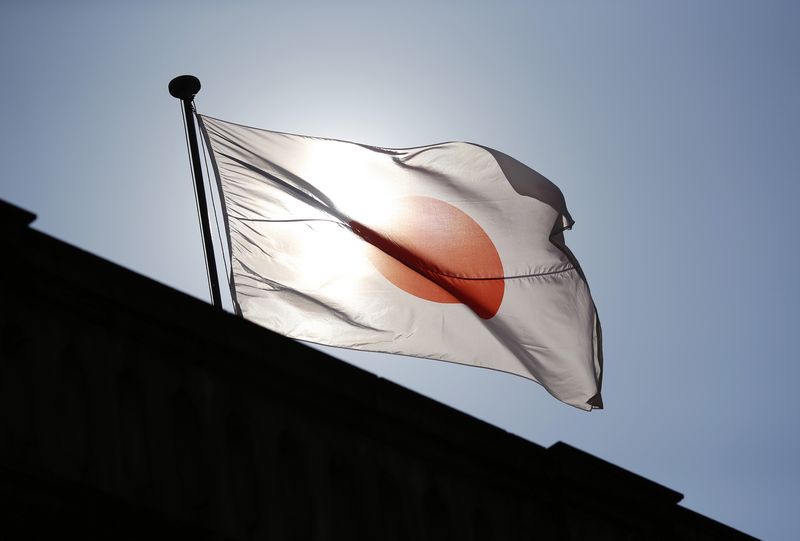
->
199, 116, 602, 410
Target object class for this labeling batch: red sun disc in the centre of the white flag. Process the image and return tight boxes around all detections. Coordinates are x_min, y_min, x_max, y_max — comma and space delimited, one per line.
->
350, 196, 505, 319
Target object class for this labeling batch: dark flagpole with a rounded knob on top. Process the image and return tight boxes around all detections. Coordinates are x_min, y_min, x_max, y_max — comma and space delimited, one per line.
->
169, 75, 222, 310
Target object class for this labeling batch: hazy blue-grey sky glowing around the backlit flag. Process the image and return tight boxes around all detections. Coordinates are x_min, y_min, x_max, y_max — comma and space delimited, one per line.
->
0, 0, 800, 539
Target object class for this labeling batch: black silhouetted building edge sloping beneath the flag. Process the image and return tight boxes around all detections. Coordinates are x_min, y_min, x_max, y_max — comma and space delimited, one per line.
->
0, 202, 750, 541
